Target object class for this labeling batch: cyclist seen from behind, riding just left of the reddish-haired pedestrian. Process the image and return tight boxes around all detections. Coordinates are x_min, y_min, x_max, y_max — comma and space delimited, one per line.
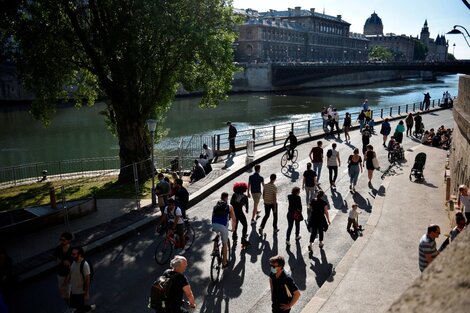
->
212, 192, 237, 268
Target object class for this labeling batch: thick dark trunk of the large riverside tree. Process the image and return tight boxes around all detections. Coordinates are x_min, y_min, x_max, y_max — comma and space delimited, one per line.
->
117, 116, 154, 183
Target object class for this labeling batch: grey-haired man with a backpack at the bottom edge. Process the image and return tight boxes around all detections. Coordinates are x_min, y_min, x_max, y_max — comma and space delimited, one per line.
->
156, 255, 196, 313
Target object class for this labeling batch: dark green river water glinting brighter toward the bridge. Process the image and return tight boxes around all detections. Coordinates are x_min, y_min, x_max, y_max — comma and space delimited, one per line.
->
0, 75, 458, 167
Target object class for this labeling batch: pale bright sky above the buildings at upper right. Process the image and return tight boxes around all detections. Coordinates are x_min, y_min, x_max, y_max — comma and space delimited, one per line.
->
233, 0, 470, 59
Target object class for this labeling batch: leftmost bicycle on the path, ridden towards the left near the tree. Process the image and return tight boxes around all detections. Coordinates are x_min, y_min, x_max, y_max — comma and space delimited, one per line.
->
154, 219, 196, 265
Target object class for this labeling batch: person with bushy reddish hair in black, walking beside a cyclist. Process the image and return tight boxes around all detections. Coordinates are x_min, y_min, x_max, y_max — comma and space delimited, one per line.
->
230, 182, 250, 246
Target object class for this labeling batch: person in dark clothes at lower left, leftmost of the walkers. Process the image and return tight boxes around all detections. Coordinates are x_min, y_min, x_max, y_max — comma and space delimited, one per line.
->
54, 232, 73, 305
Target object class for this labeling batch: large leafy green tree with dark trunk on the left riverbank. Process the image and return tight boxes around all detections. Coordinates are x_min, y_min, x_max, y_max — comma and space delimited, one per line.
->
8, 0, 236, 182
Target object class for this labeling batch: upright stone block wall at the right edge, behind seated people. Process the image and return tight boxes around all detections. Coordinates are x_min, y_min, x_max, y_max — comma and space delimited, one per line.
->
449, 75, 470, 194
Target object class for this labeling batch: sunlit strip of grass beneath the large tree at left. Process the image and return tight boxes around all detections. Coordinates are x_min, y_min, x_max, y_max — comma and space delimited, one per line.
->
0, 176, 152, 211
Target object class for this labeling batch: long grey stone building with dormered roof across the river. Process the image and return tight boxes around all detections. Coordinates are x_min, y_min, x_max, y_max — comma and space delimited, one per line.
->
235, 7, 369, 63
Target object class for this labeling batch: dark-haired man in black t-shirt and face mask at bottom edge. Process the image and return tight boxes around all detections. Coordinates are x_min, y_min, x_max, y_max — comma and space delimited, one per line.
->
269, 255, 300, 313
